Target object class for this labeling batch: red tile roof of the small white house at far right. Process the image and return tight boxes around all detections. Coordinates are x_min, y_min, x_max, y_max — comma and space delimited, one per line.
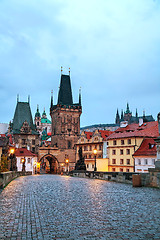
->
133, 138, 157, 156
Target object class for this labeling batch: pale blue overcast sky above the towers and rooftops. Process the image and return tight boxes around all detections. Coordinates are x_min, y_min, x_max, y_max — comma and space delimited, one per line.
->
0, 0, 160, 126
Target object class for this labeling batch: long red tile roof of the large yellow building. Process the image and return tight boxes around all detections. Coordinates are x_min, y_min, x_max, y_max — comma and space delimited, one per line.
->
108, 121, 159, 139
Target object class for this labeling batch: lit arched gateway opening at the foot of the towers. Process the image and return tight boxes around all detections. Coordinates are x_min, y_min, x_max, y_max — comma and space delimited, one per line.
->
39, 153, 60, 174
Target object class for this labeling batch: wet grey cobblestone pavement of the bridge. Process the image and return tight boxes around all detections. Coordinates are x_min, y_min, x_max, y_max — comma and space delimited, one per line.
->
0, 175, 160, 240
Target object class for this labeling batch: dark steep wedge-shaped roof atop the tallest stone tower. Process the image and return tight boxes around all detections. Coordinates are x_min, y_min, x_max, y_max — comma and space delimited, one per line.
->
57, 74, 73, 105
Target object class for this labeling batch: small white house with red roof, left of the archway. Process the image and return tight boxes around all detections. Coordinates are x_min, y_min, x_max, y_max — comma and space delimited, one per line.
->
15, 148, 37, 174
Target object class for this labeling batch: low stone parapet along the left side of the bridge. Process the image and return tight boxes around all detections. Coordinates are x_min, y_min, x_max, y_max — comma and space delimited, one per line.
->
0, 171, 32, 188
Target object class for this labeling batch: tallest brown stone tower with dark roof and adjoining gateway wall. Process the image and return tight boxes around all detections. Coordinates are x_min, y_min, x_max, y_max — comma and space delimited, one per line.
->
39, 69, 82, 173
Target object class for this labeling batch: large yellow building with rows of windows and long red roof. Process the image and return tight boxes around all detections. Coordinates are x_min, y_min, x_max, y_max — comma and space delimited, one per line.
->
107, 120, 158, 172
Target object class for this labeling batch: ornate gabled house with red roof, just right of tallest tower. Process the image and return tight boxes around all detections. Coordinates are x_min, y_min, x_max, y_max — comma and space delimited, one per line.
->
76, 130, 113, 172
